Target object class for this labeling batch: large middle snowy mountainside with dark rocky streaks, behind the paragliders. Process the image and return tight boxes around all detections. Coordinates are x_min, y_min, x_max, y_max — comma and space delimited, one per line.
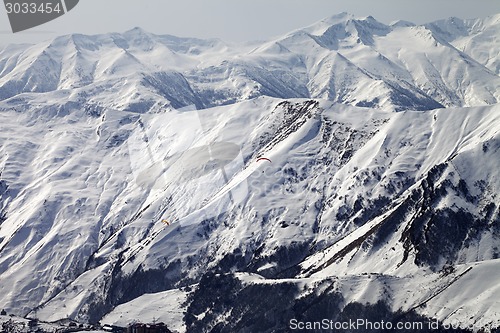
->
0, 97, 500, 326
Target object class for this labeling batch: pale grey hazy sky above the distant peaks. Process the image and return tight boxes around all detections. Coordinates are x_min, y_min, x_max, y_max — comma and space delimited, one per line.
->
0, 0, 500, 45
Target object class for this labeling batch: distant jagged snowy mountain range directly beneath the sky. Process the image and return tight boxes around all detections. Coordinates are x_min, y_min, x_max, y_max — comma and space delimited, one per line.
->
0, 14, 500, 112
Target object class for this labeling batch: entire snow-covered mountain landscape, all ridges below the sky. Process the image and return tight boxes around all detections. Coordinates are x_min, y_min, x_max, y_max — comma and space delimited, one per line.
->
0, 13, 500, 332
